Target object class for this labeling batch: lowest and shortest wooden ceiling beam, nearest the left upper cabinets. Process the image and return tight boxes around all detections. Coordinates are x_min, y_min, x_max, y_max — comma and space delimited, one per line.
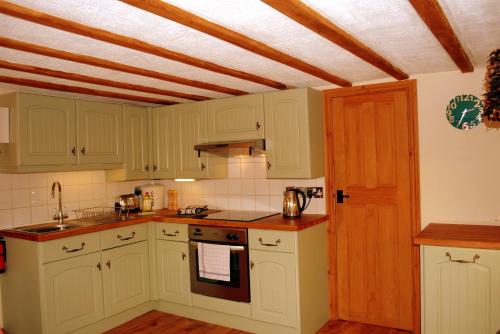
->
0, 75, 177, 105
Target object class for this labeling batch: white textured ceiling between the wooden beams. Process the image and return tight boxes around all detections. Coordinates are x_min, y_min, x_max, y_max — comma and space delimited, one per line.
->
0, 0, 500, 102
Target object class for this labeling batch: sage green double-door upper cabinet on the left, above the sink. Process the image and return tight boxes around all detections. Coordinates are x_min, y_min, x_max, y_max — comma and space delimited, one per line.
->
0, 93, 123, 173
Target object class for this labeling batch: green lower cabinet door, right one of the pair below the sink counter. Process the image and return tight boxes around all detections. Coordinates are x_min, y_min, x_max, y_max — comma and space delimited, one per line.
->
102, 241, 150, 317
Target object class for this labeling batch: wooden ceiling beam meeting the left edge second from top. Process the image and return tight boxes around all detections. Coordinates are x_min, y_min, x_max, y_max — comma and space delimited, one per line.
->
0, 37, 248, 95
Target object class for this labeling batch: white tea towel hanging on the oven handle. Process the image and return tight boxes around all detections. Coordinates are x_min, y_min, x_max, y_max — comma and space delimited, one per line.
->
198, 242, 231, 282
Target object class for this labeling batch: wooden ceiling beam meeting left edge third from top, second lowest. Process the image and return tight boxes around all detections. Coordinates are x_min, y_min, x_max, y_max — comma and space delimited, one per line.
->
0, 59, 209, 101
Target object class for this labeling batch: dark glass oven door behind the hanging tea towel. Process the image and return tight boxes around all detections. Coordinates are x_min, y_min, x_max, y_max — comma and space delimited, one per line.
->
189, 241, 250, 303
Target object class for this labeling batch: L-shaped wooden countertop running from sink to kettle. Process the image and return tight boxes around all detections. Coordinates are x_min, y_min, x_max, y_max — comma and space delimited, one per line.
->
0, 210, 328, 241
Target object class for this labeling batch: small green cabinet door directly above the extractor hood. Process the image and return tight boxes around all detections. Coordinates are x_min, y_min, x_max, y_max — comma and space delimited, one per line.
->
207, 94, 264, 142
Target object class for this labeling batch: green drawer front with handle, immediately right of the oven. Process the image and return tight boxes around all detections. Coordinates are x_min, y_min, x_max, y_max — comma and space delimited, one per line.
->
248, 229, 297, 253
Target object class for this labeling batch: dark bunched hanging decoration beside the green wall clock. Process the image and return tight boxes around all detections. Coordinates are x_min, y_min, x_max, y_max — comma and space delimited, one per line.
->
483, 49, 500, 127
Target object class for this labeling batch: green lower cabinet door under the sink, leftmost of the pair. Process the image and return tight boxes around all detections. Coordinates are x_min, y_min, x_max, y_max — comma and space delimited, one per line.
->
43, 253, 104, 334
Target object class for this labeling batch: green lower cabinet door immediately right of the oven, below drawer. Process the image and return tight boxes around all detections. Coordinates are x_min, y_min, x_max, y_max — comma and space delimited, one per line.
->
250, 250, 298, 326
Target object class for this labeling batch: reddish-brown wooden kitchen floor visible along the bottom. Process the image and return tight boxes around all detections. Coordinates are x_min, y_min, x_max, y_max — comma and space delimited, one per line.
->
104, 311, 411, 334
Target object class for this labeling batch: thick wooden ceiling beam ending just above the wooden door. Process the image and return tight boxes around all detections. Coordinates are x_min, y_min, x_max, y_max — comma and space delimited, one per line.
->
261, 0, 408, 80
